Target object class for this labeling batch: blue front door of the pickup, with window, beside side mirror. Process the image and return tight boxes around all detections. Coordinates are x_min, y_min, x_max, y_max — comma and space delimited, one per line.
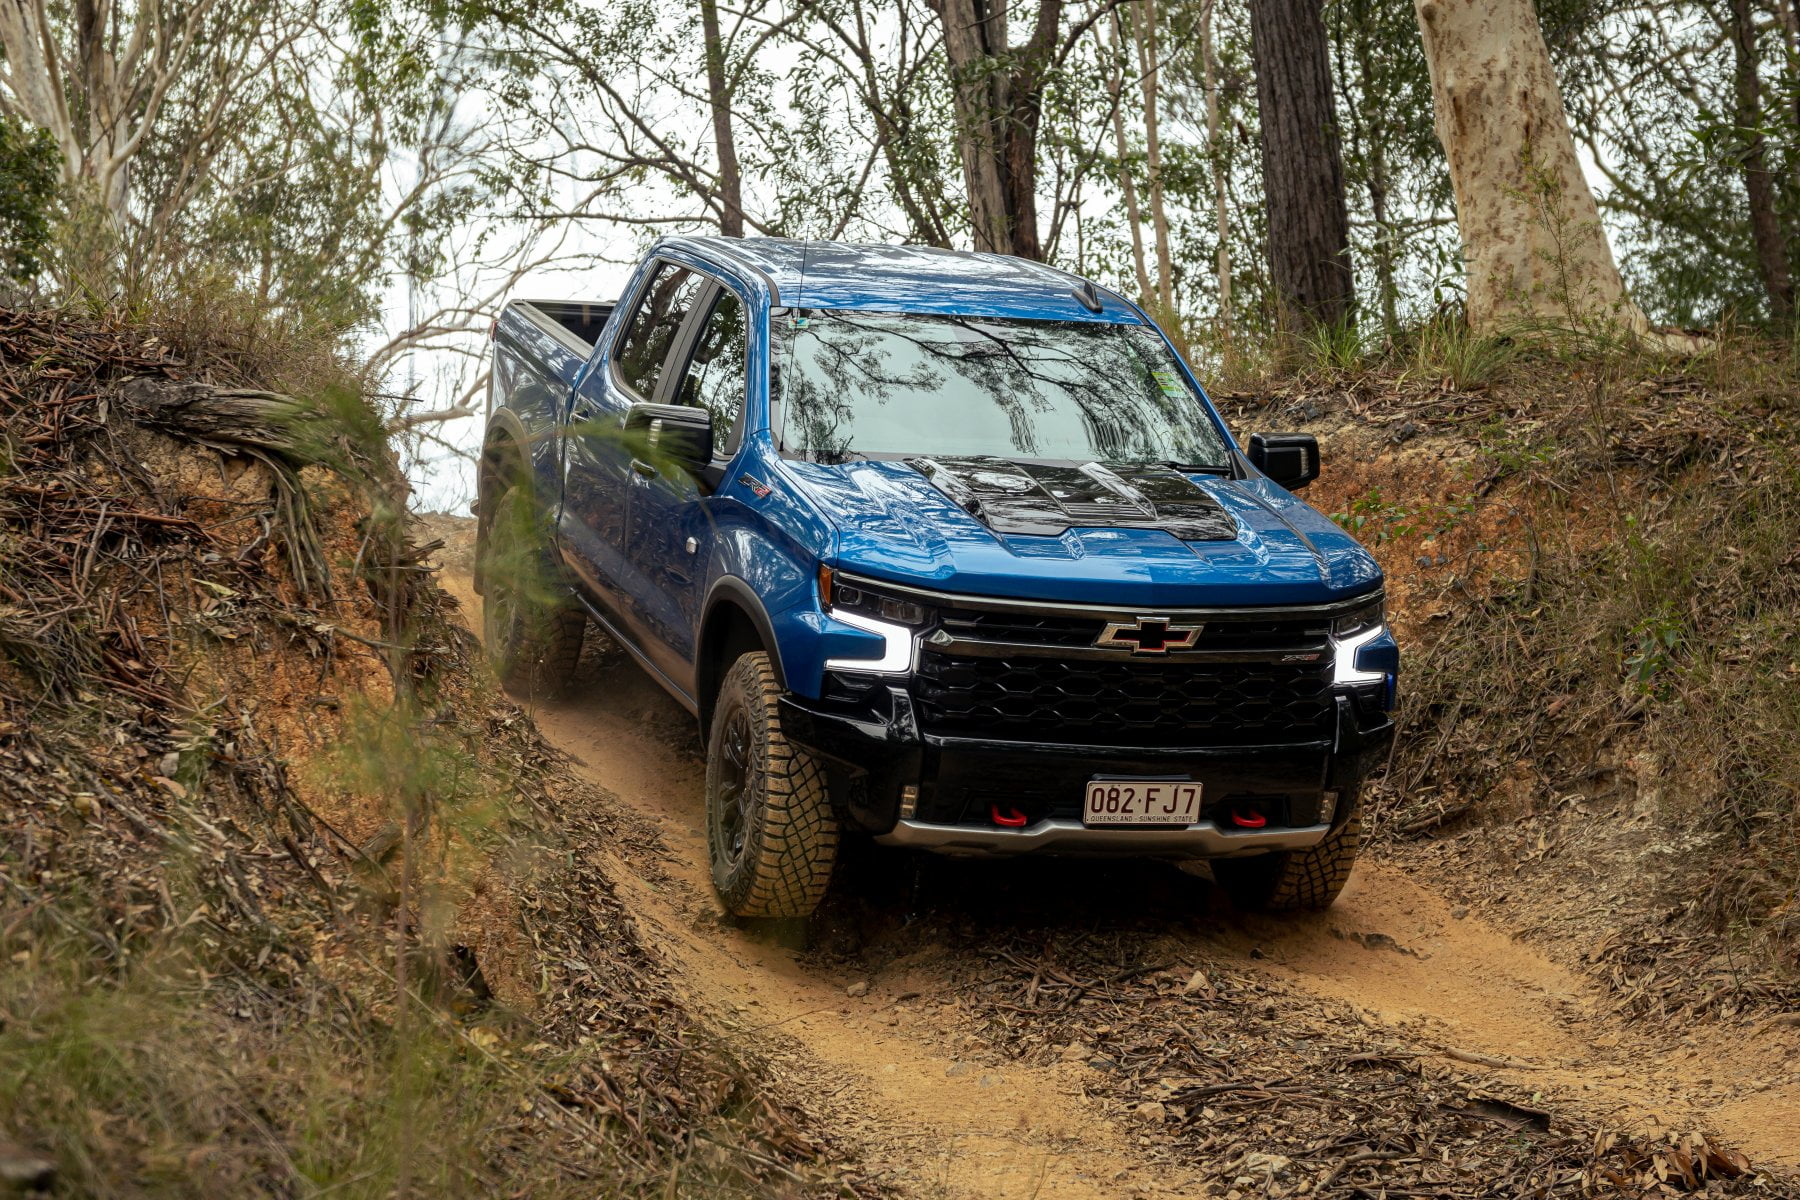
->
628, 284, 749, 687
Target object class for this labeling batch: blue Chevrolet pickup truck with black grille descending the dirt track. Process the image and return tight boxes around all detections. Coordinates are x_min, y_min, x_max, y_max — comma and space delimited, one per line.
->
475, 237, 1399, 916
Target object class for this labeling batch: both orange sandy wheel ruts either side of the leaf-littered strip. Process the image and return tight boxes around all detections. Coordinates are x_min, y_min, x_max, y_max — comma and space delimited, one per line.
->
446, 564, 1800, 1198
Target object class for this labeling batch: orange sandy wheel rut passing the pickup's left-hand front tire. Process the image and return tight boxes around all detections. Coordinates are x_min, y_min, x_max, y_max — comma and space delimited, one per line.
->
443, 576, 1193, 1200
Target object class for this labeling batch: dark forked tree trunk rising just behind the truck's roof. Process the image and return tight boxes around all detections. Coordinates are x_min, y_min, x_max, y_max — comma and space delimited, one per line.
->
931, 0, 1062, 259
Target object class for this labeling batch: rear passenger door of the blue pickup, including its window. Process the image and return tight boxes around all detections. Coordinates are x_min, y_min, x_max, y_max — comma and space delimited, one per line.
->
562, 263, 711, 636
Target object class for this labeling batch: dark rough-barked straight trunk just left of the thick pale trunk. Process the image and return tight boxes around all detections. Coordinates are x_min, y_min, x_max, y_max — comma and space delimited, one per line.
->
1249, 0, 1355, 327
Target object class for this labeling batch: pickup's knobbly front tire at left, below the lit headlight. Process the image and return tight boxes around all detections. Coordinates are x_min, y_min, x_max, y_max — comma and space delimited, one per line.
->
706, 651, 837, 918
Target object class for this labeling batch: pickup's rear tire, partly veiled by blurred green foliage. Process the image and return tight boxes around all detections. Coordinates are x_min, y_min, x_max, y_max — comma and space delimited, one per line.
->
475, 484, 587, 700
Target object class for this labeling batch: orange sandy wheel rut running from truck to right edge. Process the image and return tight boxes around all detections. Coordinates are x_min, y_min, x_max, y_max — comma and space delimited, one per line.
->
1210, 862, 1800, 1169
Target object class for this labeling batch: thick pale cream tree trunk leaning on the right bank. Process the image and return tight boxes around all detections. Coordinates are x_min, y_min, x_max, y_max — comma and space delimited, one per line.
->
1415, 0, 1649, 335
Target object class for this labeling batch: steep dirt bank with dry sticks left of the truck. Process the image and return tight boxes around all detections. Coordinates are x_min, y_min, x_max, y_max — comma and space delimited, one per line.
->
0, 311, 878, 1196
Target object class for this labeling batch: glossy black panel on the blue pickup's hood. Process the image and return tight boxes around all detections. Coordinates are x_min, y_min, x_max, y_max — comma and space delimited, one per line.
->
907, 457, 1238, 542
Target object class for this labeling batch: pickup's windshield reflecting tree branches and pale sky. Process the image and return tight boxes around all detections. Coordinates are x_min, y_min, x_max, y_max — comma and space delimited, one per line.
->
781, 311, 1226, 464
